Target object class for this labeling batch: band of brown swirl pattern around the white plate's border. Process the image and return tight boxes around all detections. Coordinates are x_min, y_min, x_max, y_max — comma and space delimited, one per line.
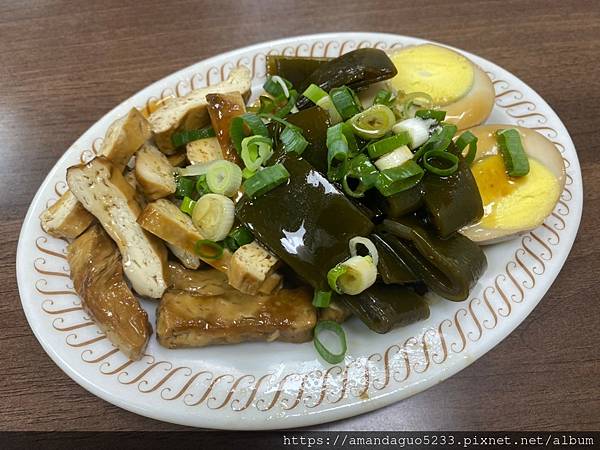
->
32, 40, 573, 411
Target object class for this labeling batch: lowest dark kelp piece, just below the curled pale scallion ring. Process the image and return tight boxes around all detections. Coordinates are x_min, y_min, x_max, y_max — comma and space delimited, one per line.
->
340, 284, 429, 334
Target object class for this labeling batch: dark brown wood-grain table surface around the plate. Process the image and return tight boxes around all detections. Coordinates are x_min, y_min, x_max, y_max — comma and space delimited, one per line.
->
0, 0, 600, 430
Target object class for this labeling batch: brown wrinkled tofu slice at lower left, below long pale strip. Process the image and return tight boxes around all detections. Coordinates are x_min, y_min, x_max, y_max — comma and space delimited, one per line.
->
67, 224, 152, 360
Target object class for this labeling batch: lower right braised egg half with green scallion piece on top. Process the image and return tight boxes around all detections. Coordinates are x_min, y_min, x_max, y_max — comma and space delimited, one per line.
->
461, 125, 565, 244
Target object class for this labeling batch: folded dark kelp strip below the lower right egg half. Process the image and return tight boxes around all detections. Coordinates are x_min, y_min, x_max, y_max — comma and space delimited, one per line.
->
378, 217, 487, 301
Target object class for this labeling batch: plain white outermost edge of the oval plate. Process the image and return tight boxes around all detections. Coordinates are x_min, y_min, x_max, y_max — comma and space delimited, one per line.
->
16, 32, 583, 429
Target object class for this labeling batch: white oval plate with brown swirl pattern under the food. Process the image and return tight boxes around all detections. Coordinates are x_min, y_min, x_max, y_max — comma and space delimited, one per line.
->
17, 33, 583, 429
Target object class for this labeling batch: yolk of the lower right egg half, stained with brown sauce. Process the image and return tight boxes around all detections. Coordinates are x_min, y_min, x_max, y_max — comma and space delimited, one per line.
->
471, 155, 560, 230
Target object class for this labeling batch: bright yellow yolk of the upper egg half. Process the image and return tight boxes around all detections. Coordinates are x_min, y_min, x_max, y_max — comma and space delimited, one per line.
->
390, 44, 474, 105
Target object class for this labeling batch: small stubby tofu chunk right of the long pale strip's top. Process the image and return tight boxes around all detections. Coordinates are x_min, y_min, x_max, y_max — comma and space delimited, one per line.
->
135, 144, 177, 201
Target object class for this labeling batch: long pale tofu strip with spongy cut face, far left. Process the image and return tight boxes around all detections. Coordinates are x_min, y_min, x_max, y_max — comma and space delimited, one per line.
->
67, 157, 167, 298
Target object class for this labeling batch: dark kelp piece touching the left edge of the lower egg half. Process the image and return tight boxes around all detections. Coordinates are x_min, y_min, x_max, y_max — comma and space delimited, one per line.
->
422, 151, 483, 237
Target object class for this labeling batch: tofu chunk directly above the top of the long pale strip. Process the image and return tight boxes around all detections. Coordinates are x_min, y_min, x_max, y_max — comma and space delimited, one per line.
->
98, 108, 152, 170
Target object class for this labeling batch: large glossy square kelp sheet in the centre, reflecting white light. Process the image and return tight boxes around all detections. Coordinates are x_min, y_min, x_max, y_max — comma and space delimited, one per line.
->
236, 154, 373, 290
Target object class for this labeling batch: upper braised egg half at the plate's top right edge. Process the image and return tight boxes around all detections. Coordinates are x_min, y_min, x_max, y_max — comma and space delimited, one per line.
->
388, 44, 495, 130
